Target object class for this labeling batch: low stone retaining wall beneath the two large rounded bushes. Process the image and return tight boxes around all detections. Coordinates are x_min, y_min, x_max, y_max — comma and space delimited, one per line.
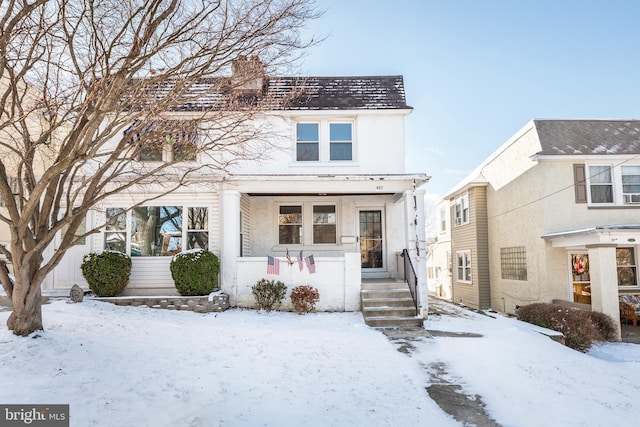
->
93, 293, 229, 313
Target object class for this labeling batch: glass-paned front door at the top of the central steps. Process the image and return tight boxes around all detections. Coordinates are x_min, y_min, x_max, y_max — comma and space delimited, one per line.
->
359, 209, 386, 271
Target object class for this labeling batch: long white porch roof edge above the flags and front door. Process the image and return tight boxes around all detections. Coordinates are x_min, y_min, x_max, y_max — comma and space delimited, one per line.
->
224, 174, 430, 196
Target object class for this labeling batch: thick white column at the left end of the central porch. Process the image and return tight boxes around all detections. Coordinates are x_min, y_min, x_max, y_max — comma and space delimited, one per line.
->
220, 190, 240, 306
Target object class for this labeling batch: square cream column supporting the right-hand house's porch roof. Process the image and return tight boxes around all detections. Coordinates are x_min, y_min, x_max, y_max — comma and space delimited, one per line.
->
587, 245, 622, 341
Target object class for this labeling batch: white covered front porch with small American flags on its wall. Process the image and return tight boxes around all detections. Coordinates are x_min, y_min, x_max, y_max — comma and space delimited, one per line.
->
220, 174, 427, 312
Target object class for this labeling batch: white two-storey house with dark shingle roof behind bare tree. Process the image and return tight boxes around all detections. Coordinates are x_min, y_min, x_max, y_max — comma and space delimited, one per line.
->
45, 59, 428, 310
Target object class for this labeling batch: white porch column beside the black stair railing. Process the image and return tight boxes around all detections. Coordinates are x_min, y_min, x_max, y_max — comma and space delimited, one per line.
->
404, 189, 429, 318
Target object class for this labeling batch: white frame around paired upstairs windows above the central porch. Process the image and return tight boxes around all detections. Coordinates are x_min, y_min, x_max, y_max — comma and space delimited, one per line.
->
292, 117, 358, 165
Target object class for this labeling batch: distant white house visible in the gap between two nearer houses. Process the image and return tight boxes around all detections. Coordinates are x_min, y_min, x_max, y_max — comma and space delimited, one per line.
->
427, 200, 453, 300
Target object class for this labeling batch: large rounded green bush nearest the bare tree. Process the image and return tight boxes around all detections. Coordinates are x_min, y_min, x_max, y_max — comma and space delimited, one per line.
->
80, 251, 131, 297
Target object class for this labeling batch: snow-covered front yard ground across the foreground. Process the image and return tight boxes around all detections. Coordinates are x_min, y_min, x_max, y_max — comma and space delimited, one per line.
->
0, 300, 640, 427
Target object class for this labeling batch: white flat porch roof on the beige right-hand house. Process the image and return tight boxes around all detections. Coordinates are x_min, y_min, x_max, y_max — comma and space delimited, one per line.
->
542, 224, 640, 248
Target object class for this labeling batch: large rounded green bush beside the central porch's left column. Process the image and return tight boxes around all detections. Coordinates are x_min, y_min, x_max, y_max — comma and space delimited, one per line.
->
169, 249, 220, 296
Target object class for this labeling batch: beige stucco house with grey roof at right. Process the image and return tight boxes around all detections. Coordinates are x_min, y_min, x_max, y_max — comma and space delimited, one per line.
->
445, 120, 640, 340
